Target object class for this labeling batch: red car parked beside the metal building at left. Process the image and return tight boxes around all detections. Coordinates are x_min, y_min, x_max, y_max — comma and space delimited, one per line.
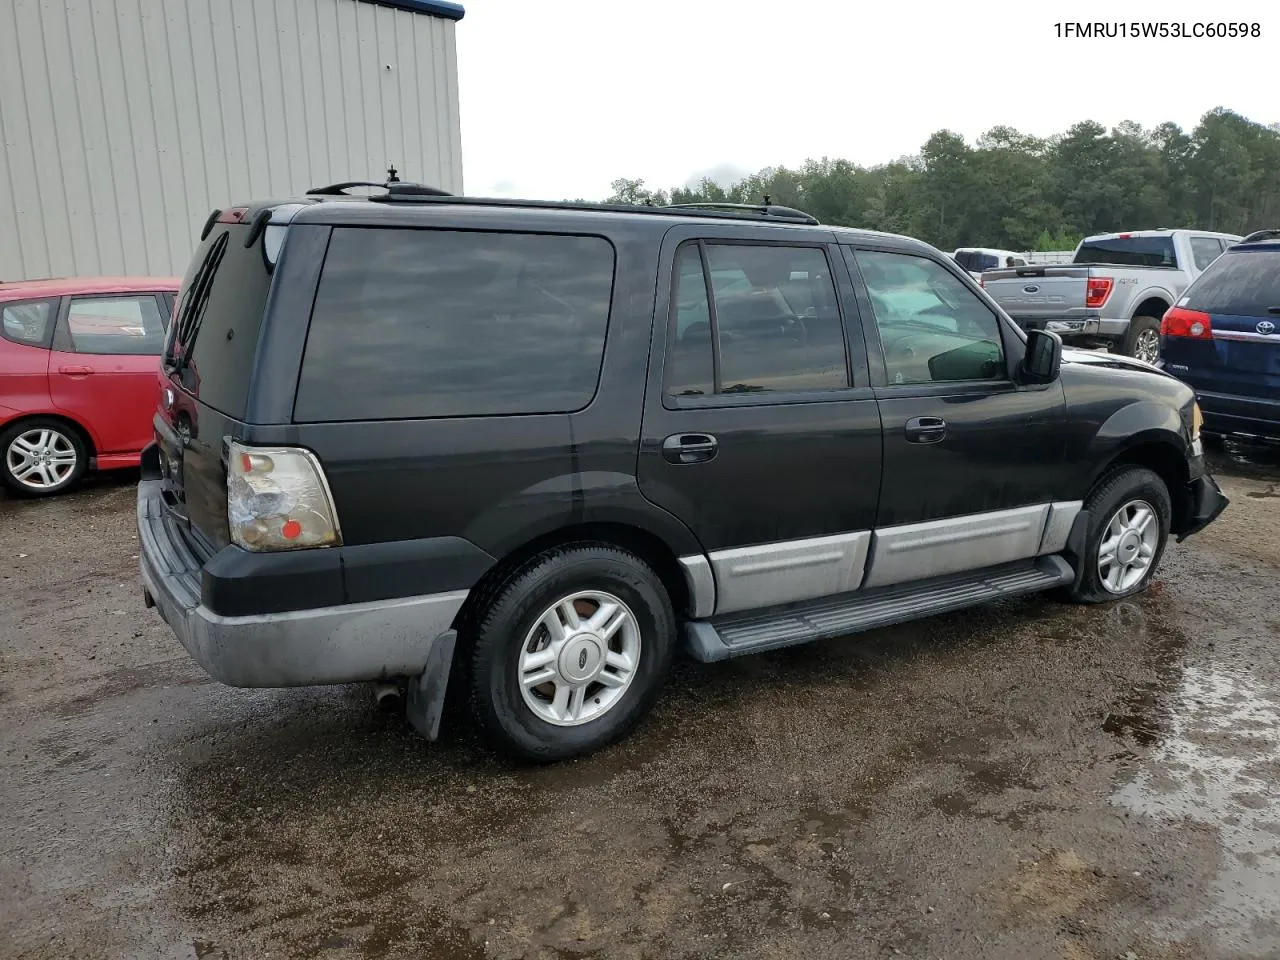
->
0, 278, 180, 497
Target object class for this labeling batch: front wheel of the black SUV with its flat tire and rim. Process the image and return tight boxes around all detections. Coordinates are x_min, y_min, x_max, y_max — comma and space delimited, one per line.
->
1068, 467, 1172, 603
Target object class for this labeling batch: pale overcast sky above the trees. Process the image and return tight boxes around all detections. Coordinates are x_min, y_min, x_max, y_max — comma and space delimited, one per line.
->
457, 0, 1280, 200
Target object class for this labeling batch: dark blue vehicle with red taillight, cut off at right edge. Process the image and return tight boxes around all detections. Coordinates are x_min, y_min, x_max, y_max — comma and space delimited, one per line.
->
1161, 230, 1280, 440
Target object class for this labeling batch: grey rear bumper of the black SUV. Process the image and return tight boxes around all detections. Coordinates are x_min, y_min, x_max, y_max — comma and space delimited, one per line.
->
137, 480, 467, 687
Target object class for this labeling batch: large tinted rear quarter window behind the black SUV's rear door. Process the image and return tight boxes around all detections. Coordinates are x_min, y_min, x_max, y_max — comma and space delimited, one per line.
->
294, 228, 613, 422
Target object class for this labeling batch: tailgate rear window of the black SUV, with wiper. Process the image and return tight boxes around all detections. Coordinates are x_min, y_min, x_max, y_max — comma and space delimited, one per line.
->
164, 223, 271, 420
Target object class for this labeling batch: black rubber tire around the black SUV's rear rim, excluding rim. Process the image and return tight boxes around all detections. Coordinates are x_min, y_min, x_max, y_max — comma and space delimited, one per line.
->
461, 543, 676, 763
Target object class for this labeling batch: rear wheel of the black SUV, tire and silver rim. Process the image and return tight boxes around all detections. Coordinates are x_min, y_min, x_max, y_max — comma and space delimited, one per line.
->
465, 544, 676, 762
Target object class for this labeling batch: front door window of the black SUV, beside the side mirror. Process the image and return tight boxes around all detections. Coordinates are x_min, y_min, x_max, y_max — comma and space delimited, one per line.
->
855, 250, 1006, 384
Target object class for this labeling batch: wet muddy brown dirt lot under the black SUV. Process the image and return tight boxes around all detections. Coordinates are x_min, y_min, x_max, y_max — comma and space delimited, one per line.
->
0, 451, 1280, 960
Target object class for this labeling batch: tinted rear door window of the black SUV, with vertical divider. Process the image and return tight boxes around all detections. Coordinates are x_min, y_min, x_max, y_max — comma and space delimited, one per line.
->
666, 243, 849, 396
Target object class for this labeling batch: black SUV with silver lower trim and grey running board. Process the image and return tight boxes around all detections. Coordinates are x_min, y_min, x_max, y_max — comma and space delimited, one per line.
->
138, 183, 1226, 760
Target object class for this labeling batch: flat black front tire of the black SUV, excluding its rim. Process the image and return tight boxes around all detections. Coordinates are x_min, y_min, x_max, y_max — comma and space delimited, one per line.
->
1066, 467, 1172, 603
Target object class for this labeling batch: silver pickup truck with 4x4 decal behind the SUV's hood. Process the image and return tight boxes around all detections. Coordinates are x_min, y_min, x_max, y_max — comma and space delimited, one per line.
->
982, 230, 1240, 364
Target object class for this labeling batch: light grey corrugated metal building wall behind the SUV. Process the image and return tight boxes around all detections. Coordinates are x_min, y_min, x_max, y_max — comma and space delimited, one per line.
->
0, 0, 462, 280
